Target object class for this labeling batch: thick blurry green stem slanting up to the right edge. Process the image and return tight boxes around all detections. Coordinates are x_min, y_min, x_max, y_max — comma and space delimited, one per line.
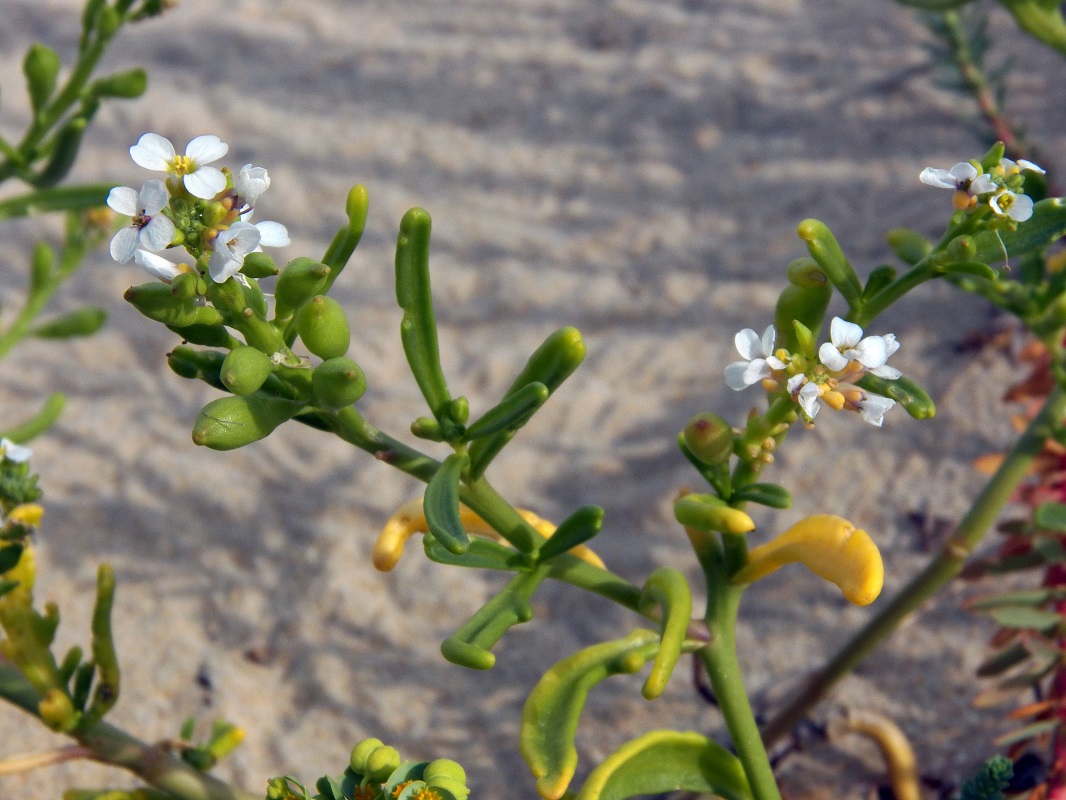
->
762, 387, 1066, 743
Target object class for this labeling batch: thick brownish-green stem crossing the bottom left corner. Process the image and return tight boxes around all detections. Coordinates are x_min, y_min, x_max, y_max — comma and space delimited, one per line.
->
0, 665, 255, 800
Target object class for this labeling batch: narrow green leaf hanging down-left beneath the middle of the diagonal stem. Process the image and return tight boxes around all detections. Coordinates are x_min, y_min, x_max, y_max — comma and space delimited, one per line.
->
440, 566, 550, 670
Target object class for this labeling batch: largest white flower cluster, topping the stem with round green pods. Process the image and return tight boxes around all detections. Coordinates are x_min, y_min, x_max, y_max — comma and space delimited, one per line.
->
108, 133, 289, 284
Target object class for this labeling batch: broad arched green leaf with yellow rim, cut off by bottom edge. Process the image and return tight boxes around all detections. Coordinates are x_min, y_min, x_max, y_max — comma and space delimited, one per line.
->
577, 731, 753, 800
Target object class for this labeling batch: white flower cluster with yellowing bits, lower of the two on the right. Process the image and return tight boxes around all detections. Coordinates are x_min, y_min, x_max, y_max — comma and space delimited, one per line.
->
726, 317, 901, 428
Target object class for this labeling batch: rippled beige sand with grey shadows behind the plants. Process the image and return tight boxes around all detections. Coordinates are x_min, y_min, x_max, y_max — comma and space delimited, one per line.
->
0, 0, 1066, 800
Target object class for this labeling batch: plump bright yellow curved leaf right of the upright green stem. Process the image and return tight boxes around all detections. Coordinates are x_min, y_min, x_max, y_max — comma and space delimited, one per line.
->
732, 514, 885, 606
